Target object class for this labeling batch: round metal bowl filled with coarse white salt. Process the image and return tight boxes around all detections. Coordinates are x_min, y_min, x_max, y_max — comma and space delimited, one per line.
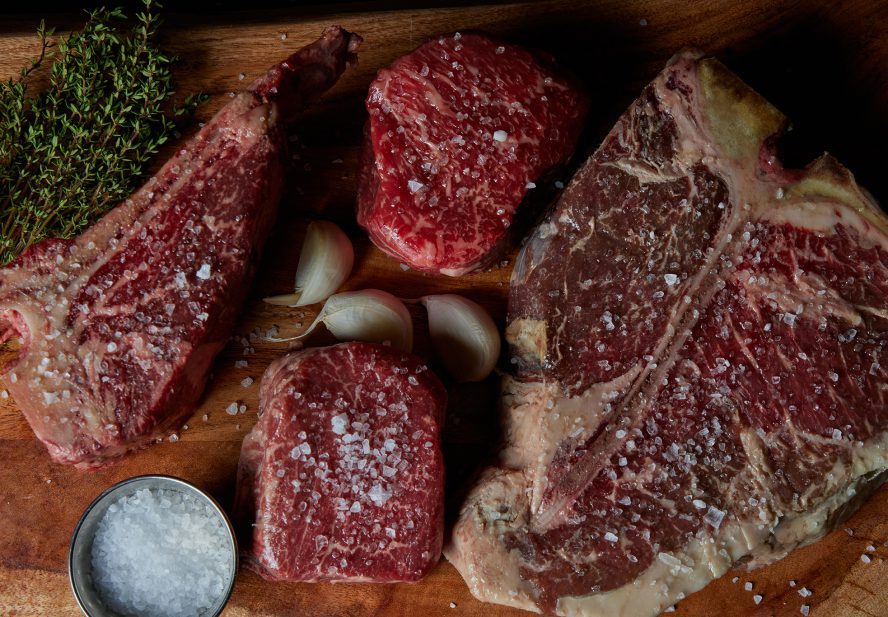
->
68, 476, 237, 617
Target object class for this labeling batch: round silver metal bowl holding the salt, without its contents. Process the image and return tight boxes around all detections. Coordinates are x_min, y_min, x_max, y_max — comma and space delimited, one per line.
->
68, 476, 237, 617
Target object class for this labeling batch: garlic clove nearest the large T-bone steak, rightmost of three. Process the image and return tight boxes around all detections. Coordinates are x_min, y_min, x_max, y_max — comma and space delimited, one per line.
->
420, 294, 501, 381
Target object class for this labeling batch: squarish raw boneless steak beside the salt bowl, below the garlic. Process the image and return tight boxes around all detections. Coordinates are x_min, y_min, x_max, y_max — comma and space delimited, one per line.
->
236, 343, 446, 583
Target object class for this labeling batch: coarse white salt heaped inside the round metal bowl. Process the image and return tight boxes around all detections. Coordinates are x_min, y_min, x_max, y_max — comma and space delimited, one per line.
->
91, 489, 232, 617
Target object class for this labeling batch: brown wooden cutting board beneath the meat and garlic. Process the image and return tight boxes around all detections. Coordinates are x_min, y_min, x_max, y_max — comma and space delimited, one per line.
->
0, 0, 888, 617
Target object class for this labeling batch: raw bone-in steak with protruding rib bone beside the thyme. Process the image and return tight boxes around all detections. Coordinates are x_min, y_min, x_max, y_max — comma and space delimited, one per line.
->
0, 27, 360, 467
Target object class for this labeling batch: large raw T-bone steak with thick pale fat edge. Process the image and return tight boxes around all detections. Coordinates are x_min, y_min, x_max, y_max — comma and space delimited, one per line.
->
447, 52, 888, 617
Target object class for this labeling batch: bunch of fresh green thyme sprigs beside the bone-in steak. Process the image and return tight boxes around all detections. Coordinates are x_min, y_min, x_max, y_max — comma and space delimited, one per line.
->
0, 0, 205, 263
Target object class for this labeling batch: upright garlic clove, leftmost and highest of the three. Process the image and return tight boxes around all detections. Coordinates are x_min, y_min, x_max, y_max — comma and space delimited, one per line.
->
265, 221, 355, 307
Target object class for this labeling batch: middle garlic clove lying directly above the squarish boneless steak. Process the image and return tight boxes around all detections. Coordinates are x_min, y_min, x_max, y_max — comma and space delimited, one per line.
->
296, 289, 413, 352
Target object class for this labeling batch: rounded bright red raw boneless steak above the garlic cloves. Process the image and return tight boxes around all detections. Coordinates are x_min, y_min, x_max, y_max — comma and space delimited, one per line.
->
358, 32, 586, 276
